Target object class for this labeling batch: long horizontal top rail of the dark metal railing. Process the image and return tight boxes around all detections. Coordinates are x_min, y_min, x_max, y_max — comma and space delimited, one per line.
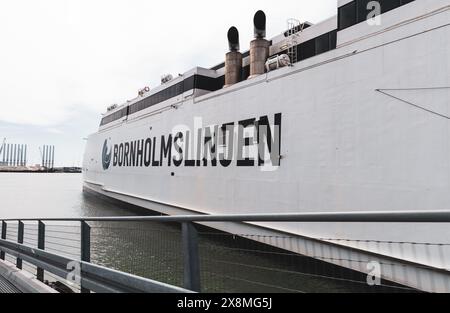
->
2, 210, 450, 223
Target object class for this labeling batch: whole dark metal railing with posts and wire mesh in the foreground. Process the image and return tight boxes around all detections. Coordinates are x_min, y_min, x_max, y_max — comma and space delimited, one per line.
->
0, 211, 450, 292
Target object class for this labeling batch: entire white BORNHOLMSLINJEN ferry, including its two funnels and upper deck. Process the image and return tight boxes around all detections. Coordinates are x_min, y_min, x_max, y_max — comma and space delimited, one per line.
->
83, 0, 450, 291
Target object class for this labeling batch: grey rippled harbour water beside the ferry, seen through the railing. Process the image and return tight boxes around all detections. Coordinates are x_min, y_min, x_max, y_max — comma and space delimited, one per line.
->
0, 173, 412, 293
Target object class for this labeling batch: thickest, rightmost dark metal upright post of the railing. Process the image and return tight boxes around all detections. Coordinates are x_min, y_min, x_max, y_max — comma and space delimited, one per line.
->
182, 222, 201, 292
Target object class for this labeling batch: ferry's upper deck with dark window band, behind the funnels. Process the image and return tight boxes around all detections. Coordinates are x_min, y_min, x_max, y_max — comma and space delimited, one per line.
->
100, 0, 416, 129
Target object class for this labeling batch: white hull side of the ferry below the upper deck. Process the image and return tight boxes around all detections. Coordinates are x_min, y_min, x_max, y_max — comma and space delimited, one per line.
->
83, 1, 450, 288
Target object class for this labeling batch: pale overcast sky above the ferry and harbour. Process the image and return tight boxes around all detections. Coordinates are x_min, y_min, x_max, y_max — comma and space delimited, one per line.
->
0, 0, 337, 166
